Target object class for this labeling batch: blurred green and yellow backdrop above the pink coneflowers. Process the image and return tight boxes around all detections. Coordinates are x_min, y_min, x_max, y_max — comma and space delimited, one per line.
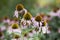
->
0, 0, 60, 18
